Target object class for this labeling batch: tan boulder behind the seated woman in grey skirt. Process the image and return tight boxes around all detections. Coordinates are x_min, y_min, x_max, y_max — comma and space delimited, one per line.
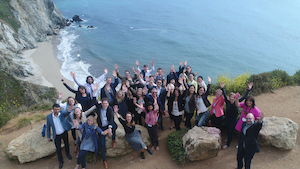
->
99, 116, 150, 157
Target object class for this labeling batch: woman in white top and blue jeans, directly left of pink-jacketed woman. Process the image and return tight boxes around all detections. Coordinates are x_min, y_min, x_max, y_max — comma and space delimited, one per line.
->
197, 76, 211, 127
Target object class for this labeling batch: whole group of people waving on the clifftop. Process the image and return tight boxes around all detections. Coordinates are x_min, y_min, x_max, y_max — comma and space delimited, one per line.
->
47, 60, 264, 169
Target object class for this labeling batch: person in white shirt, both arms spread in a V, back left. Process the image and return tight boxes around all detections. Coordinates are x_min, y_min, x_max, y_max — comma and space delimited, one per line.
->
70, 69, 107, 99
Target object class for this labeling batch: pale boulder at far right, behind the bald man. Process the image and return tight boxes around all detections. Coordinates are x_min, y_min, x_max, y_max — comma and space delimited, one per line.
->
257, 116, 299, 150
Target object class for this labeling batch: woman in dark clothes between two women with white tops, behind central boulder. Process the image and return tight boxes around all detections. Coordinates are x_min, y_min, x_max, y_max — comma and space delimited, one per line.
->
184, 85, 198, 129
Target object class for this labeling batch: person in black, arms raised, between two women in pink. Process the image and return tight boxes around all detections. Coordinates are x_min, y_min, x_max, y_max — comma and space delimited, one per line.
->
220, 82, 253, 149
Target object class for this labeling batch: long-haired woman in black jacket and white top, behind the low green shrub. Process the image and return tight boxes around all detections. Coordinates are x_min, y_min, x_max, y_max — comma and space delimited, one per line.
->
167, 85, 184, 130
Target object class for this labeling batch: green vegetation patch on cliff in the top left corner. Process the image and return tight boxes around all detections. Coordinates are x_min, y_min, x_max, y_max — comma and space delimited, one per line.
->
0, 0, 20, 32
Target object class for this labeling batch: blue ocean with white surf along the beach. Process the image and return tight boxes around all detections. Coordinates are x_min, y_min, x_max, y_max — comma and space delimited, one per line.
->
52, 0, 300, 86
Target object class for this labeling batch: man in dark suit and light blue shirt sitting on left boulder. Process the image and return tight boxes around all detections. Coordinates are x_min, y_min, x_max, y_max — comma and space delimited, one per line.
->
87, 98, 118, 169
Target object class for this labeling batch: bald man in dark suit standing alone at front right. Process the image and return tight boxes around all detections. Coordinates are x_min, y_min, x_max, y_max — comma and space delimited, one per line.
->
237, 112, 264, 169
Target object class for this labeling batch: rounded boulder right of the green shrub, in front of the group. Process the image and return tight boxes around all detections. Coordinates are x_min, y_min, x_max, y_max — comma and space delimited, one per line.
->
182, 126, 221, 161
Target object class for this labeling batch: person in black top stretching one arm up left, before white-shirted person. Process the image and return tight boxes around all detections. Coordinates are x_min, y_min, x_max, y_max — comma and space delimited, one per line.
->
62, 79, 92, 111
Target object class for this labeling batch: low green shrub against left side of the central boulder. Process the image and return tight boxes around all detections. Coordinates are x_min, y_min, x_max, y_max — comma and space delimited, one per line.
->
167, 128, 188, 165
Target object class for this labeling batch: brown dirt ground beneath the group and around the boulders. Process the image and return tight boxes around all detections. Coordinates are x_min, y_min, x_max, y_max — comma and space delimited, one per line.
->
0, 86, 300, 169
